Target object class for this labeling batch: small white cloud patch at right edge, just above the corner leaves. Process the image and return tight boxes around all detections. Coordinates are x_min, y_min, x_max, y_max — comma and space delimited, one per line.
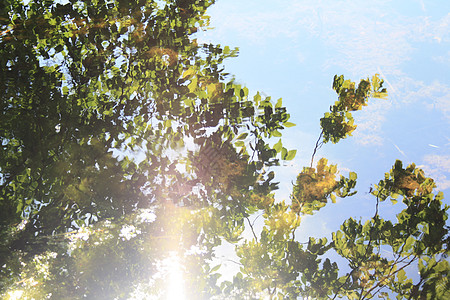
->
420, 154, 450, 190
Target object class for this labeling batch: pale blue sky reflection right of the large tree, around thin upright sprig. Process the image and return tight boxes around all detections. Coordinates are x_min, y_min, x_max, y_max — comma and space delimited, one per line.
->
199, 0, 450, 243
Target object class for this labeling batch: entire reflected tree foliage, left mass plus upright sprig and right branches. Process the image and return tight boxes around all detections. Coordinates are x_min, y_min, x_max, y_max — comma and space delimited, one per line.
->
0, 0, 449, 299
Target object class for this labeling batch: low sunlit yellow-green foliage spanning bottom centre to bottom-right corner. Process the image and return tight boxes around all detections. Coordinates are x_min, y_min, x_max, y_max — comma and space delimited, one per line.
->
225, 161, 450, 299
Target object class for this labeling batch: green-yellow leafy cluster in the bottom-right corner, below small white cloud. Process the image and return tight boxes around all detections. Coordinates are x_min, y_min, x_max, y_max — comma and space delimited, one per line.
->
326, 161, 450, 299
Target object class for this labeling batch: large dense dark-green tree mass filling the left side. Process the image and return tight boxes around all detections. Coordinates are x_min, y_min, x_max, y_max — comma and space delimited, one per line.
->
0, 1, 289, 298
